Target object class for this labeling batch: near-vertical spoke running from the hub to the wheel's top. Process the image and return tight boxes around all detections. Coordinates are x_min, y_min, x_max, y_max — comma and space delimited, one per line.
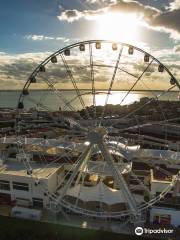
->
89, 43, 96, 124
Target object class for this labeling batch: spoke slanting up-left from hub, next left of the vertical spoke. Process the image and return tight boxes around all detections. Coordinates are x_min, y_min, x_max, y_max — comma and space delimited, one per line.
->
60, 54, 89, 118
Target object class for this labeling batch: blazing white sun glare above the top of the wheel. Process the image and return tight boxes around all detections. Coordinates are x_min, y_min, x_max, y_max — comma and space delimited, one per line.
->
96, 13, 140, 43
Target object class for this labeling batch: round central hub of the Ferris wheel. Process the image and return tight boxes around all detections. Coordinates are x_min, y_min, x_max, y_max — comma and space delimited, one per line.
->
88, 127, 107, 144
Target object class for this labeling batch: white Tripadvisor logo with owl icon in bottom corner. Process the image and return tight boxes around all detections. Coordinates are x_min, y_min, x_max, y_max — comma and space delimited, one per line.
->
135, 227, 174, 236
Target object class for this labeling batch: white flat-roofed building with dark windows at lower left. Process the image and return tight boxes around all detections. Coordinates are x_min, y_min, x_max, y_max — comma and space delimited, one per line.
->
0, 158, 64, 208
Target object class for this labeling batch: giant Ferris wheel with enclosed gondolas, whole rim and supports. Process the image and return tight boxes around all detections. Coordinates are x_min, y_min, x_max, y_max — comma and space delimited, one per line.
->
16, 40, 180, 221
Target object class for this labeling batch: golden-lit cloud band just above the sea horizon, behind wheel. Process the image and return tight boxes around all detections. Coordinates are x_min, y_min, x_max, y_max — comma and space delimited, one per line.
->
0, 45, 180, 89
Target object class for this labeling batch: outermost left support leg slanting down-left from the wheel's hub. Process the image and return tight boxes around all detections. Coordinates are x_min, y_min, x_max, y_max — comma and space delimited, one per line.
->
58, 144, 92, 200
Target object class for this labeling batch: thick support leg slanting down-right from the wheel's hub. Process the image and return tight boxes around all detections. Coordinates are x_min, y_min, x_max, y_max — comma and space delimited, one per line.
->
98, 142, 138, 216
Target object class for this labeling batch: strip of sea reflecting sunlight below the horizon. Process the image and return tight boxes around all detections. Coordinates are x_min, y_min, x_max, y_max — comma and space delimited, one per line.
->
0, 90, 179, 110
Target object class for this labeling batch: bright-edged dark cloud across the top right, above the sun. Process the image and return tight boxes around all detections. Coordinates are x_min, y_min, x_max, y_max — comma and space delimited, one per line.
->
58, 0, 180, 38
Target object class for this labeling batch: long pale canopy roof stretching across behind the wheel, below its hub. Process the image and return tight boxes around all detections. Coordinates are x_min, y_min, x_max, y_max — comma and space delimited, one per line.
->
0, 137, 180, 162
